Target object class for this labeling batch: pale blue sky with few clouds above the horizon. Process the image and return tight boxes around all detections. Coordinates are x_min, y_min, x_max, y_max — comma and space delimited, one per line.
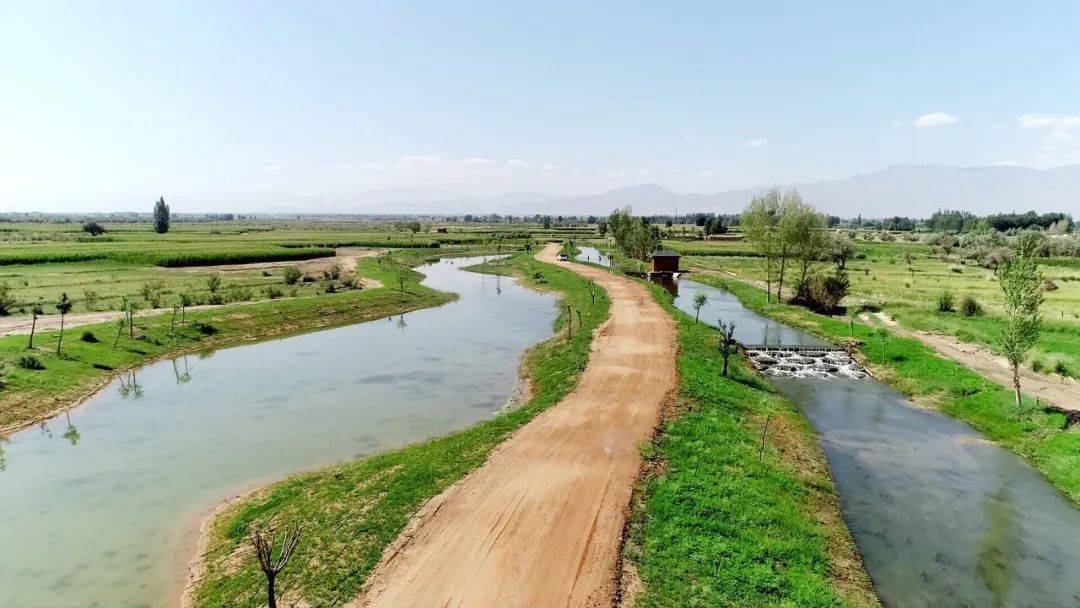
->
0, 0, 1080, 212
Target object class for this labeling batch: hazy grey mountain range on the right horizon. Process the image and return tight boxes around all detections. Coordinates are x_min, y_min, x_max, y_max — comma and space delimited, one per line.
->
507, 165, 1080, 217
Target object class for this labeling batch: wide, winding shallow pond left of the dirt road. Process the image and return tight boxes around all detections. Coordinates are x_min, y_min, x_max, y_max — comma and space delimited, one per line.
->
0, 258, 556, 607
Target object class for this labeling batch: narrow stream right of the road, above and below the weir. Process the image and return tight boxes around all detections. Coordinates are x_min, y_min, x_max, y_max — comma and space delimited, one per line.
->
676, 280, 1080, 608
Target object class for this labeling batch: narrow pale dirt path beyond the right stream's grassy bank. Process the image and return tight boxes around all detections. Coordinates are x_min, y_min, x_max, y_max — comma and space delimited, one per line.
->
864, 312, 1080, 411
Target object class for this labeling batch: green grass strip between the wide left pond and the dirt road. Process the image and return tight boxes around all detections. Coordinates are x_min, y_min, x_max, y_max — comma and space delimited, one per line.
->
194, 254, 610, 607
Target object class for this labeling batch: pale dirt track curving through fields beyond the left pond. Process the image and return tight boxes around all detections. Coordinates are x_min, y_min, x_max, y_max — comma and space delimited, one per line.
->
0, 247, 382, 337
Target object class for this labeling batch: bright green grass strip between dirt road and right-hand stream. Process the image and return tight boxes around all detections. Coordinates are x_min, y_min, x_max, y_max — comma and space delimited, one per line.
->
627, 280, 877, 608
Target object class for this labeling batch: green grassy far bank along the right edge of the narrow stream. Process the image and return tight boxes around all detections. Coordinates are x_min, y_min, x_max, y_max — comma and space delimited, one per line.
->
694, 276, 1080, 502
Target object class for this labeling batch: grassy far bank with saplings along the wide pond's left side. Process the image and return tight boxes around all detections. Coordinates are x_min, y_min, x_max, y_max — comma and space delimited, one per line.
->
0, 253, 450, 430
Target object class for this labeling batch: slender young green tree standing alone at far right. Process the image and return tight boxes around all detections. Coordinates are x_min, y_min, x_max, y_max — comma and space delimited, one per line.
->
998, 243, 1043, 407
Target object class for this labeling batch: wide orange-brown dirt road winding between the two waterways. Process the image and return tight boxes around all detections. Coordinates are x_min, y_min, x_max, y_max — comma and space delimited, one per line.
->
349, 245, 676, 608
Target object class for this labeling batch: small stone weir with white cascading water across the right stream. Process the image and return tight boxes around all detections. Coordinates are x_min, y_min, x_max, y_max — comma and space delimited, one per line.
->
743, 344, 869, 379
